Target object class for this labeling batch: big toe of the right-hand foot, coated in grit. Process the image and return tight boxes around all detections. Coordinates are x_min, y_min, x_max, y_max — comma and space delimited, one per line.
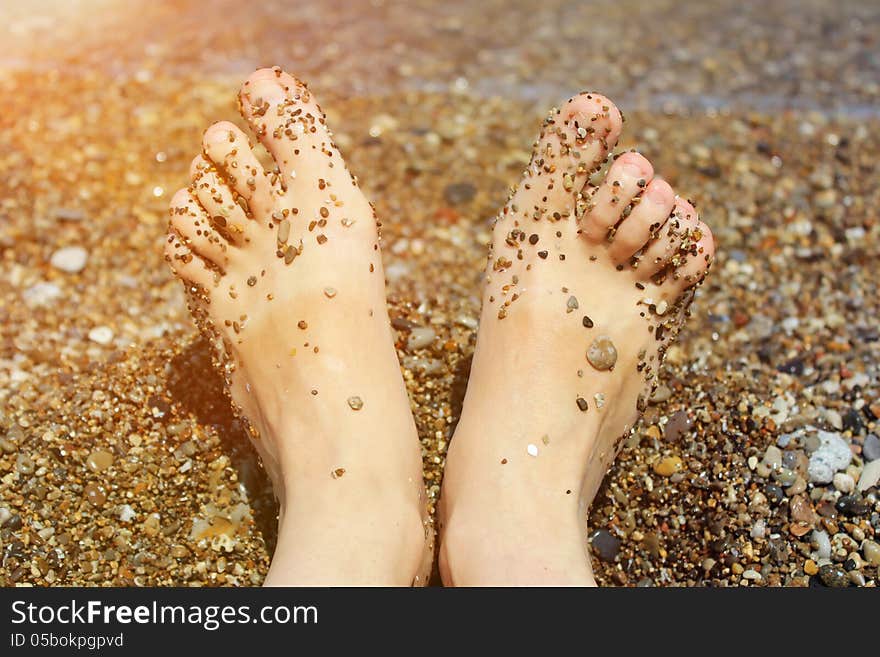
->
528, 93, 623, 206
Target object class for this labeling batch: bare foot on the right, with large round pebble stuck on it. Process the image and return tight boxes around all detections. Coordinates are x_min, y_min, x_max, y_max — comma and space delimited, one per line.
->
440, 94, 714, 585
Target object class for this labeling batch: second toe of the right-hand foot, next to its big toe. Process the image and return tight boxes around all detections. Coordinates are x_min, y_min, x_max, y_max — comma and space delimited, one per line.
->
581, 153, 654, 242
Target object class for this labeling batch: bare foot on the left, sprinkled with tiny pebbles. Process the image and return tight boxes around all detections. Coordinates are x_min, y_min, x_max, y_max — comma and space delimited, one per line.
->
165, 69, 432, 585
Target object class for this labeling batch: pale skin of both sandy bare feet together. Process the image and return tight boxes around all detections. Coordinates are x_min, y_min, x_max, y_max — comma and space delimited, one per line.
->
166, 69, 714, 586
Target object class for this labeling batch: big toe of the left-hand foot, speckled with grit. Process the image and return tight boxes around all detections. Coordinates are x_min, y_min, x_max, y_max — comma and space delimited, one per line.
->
239, 68, 345, 192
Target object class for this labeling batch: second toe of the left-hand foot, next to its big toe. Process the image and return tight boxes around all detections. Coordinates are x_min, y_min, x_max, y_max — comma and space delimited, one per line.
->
202, 121, 272, 218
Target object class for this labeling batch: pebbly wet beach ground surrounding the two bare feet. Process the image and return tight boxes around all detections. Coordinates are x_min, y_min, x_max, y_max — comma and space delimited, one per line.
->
0, 0, 880, 586
